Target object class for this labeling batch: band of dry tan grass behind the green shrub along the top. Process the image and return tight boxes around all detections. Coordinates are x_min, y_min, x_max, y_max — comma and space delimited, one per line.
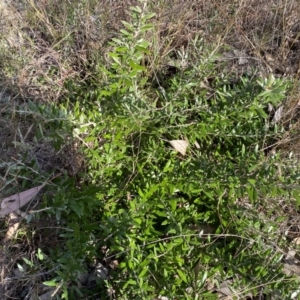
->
0, 0, 300, 101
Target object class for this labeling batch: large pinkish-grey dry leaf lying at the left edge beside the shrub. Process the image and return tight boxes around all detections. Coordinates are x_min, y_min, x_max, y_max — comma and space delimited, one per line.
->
0, 185, 43, 218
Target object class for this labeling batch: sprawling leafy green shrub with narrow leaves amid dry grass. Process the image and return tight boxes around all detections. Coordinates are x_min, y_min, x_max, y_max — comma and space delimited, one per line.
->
1, 1, 299, 299
